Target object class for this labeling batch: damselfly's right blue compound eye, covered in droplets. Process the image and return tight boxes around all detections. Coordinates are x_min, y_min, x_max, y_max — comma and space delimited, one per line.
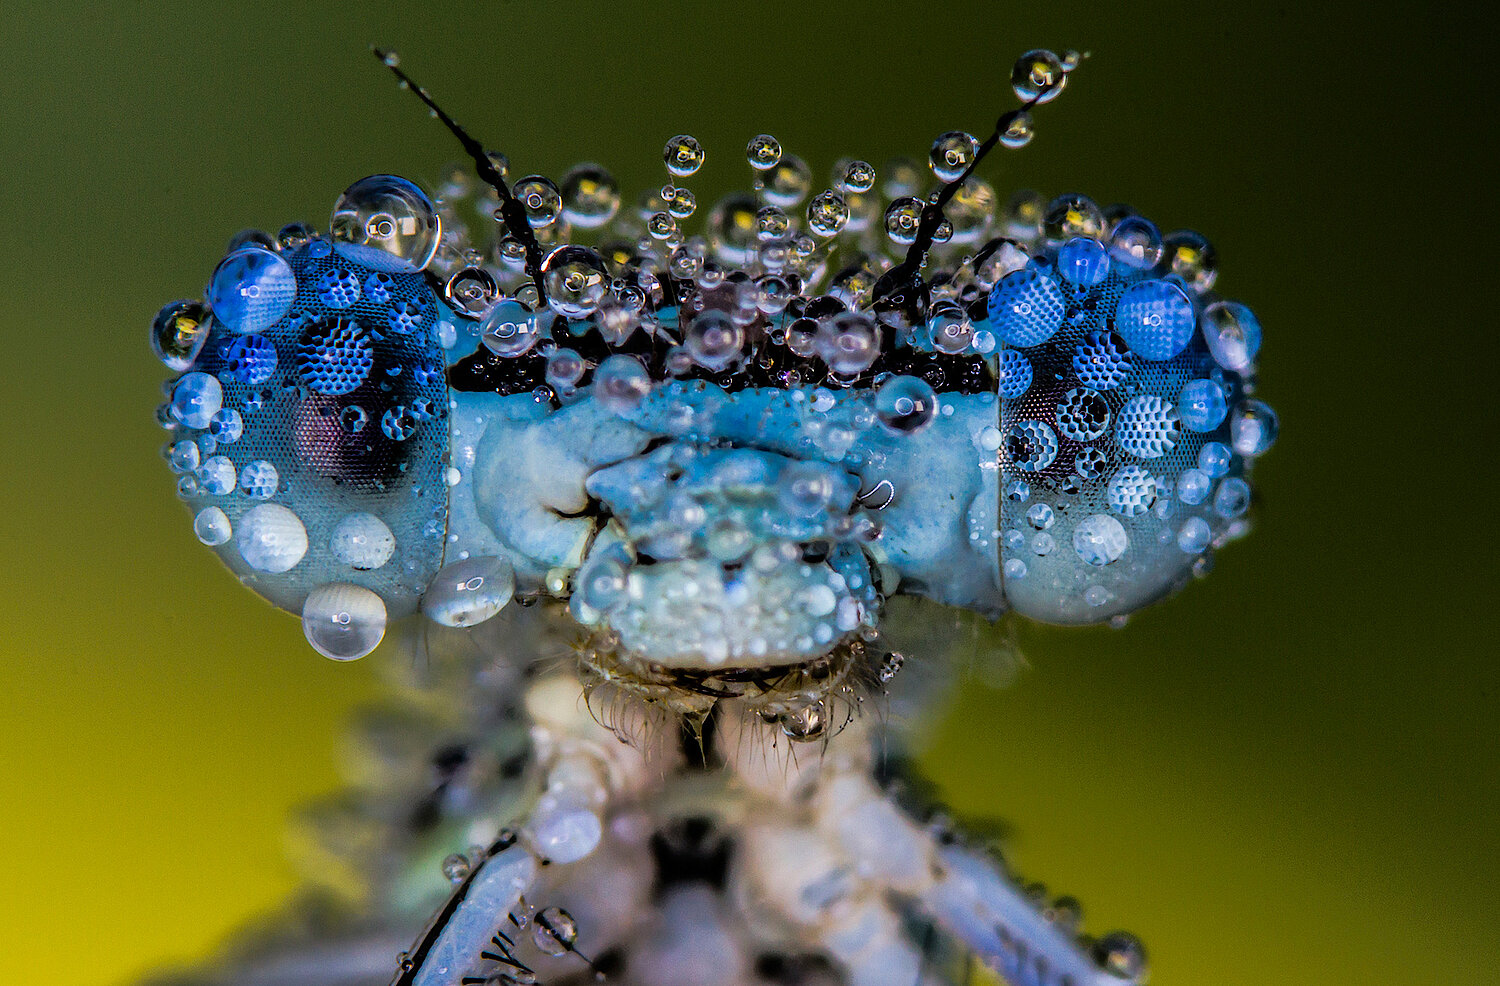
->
989, 218, 1277, 624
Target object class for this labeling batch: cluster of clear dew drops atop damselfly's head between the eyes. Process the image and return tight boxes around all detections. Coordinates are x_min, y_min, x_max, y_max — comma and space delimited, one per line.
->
370, 50, 1097, 431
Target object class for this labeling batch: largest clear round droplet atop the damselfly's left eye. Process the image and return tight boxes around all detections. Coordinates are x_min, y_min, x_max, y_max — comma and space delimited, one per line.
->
329, 174, 443, 270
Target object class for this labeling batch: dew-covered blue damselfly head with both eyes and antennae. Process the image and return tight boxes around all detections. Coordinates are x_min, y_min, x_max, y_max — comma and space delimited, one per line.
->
153, 49, 1277, 714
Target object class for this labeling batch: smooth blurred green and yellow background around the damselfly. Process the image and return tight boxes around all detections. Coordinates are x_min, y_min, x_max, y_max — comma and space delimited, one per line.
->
0, 0, 1500, 986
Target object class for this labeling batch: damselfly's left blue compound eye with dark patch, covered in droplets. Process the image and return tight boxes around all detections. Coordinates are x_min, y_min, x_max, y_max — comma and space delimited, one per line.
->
156, 176, 450, 657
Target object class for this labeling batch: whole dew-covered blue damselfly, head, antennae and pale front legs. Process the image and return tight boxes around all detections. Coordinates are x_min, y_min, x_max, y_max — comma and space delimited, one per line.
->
153, 51, 1277, 986
